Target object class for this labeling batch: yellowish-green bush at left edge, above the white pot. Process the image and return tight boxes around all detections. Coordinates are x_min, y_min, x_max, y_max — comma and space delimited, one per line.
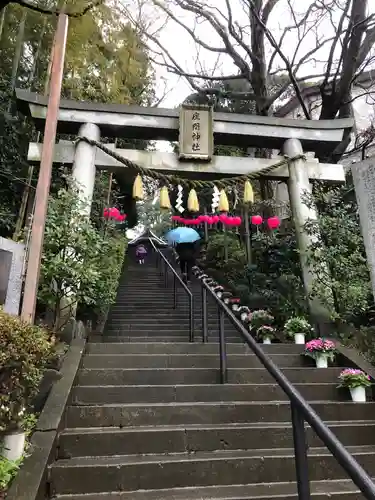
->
0, 310, 55, 431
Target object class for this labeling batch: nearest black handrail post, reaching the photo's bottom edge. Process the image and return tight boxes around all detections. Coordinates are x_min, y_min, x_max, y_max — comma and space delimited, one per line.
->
290, 402, 311, 500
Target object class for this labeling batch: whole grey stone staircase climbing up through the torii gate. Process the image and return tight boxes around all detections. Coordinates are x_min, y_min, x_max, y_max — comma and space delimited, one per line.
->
48, 254, 375, 500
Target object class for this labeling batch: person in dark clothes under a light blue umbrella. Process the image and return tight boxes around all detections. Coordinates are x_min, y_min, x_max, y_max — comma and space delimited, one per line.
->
166, 227, 201, 283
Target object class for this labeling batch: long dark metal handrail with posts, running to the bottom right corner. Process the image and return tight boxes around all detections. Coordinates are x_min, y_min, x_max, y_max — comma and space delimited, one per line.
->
197, 268, 375, 500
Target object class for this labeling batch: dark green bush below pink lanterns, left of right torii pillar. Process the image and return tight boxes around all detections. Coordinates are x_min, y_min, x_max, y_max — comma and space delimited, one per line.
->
204, 227, 307, 326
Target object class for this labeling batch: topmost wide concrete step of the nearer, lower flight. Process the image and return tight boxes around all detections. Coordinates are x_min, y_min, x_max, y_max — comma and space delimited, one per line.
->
86, 342, 304, 354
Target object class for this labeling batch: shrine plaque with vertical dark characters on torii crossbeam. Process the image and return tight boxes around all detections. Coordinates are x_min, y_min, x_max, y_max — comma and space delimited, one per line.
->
179, 104, 214, 161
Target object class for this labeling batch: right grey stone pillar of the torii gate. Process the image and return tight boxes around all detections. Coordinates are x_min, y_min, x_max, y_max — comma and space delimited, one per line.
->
283, 139, 330, 334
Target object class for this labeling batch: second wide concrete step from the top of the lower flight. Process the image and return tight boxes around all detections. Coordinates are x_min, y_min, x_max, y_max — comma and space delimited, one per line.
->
82, 353, 309, 368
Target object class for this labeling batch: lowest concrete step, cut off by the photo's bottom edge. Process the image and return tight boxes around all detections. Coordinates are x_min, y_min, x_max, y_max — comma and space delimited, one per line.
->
51, 479, 364, 500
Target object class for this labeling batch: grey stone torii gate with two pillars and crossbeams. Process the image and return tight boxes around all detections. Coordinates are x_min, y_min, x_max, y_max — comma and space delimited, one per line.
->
16, 89, 354, 326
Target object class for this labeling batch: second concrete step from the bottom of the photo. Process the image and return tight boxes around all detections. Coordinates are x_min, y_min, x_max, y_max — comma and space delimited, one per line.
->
50, 446, 375, 494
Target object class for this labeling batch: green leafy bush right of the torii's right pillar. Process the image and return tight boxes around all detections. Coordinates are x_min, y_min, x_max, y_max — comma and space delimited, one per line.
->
305, 184, 374, 324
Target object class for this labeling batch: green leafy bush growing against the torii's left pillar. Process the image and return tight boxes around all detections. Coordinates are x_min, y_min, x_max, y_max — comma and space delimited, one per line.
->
38, 179, 126, 331
